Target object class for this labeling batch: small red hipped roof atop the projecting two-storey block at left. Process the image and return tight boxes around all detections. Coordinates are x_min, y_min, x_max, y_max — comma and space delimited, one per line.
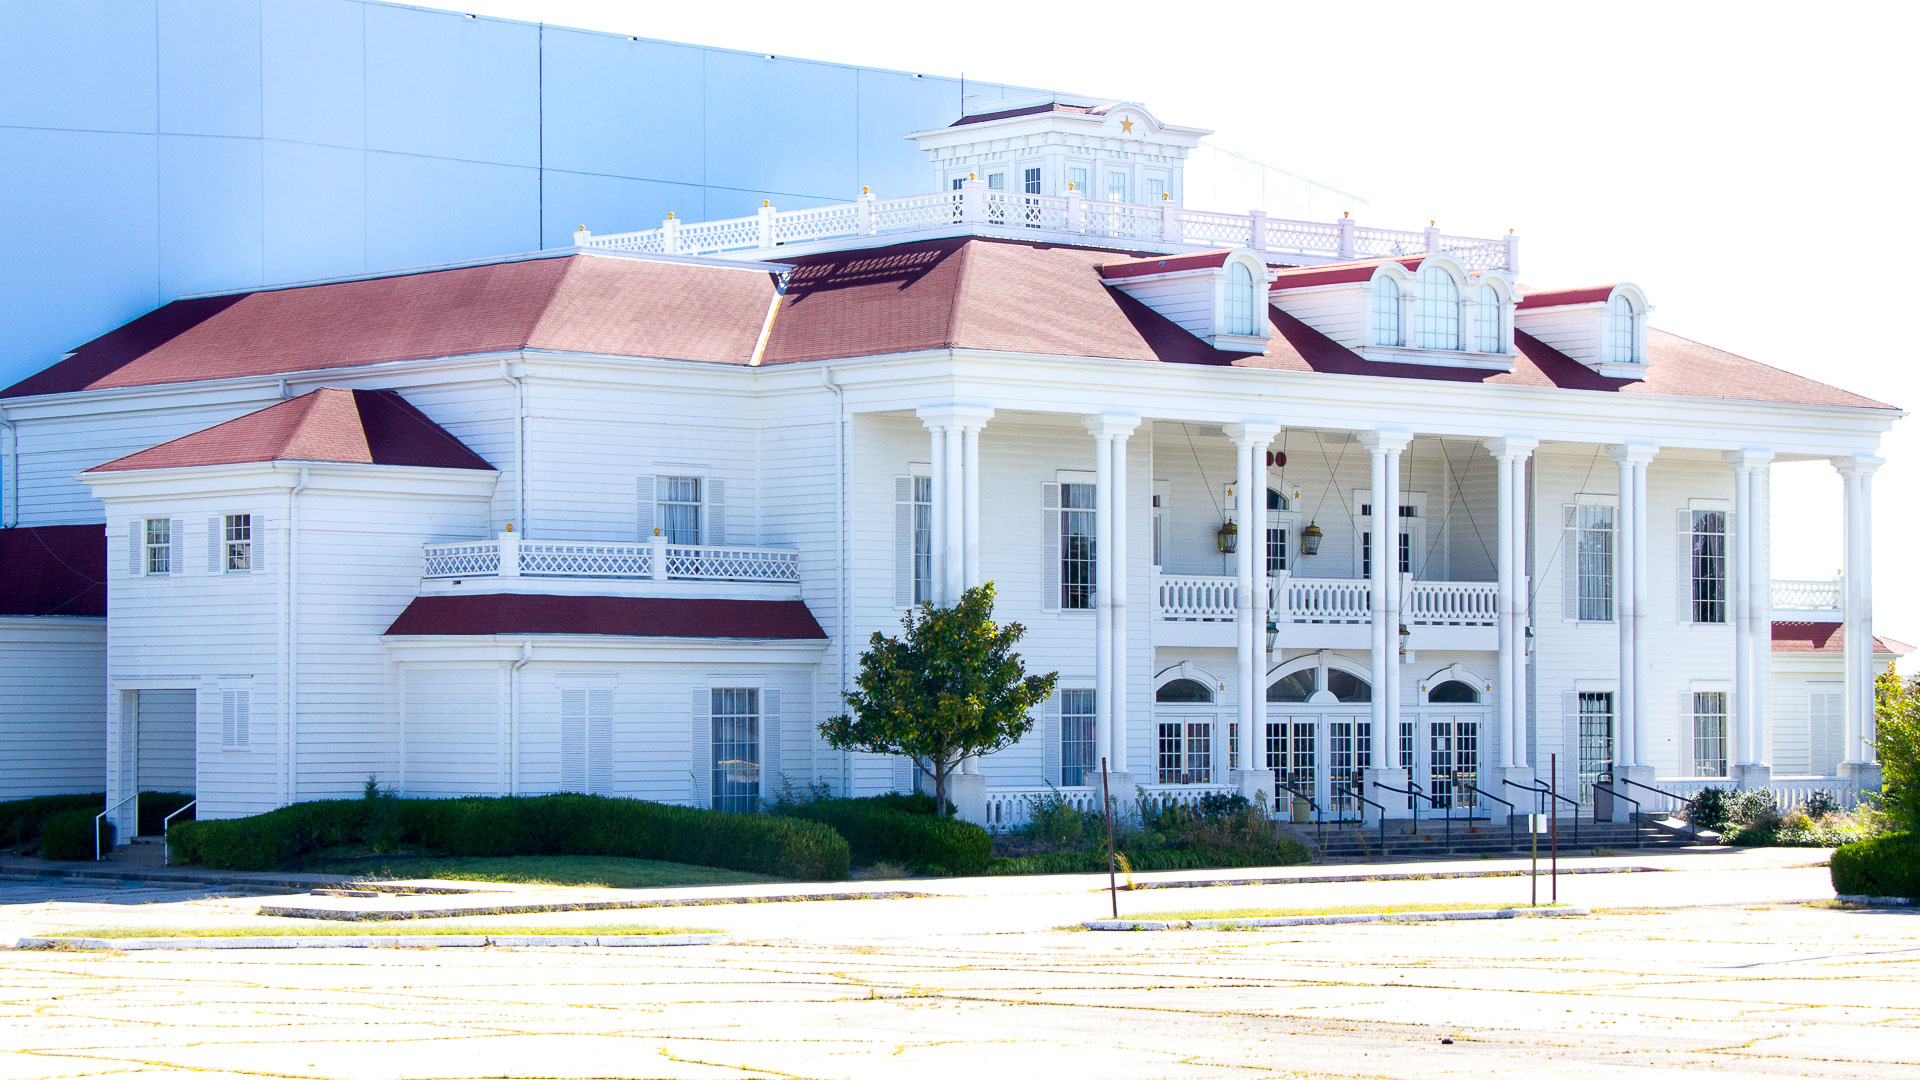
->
88, 386, 493, 473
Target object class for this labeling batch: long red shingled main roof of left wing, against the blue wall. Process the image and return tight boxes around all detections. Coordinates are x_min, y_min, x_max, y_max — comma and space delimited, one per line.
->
0, 256, 774, 398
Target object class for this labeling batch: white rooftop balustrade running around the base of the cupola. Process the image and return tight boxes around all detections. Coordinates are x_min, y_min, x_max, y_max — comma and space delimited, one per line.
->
574, 181, 1519, 271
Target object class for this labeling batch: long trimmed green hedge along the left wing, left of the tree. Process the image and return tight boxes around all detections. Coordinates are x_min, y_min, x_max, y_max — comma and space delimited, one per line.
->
167, 796, 849, 878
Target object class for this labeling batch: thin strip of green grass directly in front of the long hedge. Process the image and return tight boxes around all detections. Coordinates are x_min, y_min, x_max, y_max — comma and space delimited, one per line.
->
292, 855, 783, 888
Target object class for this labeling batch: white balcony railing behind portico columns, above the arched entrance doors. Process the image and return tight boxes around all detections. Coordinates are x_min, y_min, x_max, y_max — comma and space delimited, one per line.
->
1154, 573, 1500, 626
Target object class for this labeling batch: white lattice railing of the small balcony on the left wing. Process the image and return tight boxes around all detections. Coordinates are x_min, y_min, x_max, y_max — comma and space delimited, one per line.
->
422, 532, 801, 584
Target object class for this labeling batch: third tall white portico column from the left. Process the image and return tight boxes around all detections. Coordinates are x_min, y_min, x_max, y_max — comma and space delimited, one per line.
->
1227, 421, 1281, 798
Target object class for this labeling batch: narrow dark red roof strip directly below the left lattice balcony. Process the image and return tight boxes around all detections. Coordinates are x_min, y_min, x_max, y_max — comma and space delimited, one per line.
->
386, 592, 828, 640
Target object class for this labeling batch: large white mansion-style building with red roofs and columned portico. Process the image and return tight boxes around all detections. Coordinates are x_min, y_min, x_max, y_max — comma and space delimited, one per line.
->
0, 102, 1901, 832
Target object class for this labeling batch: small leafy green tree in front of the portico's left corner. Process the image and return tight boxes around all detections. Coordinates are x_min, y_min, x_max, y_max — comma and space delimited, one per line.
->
820, 582, 1060, 809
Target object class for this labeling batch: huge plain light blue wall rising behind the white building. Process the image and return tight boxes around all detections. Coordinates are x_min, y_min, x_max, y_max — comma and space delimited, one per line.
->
0, 0, 1029, 386
